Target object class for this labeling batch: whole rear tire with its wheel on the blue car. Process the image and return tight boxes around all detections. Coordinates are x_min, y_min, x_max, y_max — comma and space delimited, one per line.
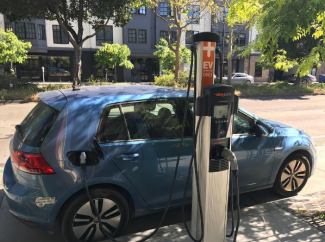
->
60, 188, 130, 242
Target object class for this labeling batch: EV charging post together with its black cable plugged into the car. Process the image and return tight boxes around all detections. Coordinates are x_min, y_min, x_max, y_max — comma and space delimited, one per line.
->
67, 32, 240, 242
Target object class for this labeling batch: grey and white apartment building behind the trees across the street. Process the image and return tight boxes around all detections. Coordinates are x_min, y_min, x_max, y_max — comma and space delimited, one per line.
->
0, 3, 268, 82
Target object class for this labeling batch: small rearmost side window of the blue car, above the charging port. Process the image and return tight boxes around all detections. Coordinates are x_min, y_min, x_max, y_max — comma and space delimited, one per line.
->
97, 105, 128, 143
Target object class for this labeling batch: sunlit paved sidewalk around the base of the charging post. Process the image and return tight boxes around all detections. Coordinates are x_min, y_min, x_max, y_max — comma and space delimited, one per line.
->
0, 190, 325, 242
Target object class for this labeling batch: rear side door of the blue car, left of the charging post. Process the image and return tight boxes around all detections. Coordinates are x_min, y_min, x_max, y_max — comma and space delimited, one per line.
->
100, 100, 193, 208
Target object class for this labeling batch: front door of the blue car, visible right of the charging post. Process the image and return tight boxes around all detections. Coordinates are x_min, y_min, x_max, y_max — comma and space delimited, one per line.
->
232, 112, 274, 192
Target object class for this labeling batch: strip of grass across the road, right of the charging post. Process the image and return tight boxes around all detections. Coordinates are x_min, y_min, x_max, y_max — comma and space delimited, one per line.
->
234, 82, 325, 96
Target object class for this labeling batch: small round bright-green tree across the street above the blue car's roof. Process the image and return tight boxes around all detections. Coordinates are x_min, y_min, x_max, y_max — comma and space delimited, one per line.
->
95, 43, 133, 82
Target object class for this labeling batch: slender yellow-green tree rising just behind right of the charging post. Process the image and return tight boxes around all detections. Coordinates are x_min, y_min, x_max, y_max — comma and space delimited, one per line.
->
216, 0, 262, 85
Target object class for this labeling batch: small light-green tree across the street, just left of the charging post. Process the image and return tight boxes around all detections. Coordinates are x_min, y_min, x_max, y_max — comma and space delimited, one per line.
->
153, 38, 191, 73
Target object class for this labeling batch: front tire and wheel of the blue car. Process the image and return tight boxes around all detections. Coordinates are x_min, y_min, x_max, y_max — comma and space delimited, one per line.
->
273, 155, 310, 197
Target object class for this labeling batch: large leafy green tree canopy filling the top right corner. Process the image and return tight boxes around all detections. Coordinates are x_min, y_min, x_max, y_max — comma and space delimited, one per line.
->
247, 0, 325, 84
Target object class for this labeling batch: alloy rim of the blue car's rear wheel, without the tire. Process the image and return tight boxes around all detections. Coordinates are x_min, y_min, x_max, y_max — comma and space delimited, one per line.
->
72, 198, 121, 242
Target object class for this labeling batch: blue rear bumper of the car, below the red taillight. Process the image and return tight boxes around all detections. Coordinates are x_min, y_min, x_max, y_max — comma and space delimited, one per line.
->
3, 158, 71, 232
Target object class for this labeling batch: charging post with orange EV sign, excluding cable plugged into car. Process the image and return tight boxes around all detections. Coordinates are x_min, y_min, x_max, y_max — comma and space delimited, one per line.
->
191, 33, 238, 242
